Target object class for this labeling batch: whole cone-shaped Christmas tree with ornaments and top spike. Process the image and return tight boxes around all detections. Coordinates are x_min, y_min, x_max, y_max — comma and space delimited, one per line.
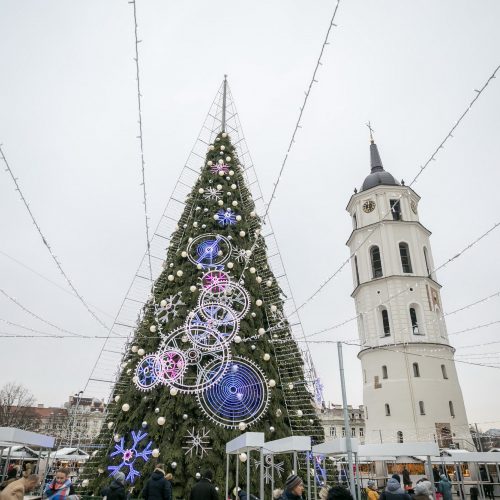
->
87, 78, 323, 498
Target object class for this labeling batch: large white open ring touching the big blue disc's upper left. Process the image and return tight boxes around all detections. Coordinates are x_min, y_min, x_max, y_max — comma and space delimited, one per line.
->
158, 328, 231, 394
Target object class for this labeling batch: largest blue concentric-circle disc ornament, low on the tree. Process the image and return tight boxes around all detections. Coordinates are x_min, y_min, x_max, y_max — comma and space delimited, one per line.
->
196, 357, 270, 429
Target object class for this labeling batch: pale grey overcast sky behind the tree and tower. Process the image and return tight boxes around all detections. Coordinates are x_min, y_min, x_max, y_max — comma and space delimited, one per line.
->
0, 0, 500, 429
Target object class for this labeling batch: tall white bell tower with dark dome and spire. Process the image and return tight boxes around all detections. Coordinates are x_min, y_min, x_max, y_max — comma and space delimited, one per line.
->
347, 138, 473, 448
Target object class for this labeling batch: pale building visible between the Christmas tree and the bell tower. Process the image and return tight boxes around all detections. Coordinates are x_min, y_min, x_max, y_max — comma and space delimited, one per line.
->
318, 403, 365, 444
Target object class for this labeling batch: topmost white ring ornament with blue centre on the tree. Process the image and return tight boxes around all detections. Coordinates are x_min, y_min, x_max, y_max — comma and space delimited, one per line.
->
187, 233, 232, 269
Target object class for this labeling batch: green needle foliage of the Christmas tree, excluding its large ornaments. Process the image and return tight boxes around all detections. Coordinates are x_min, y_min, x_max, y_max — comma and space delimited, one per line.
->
86, 134, 323, 498
